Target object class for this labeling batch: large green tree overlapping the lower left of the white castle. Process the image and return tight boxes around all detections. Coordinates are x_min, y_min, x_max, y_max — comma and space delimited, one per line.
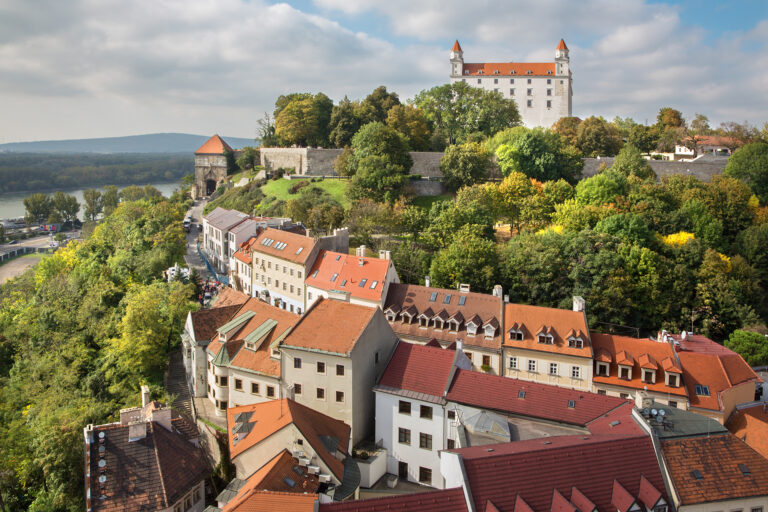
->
413, 82, 520, 144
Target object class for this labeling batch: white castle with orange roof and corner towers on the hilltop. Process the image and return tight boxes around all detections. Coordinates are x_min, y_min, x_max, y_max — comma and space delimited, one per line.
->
451, 39, 573, 128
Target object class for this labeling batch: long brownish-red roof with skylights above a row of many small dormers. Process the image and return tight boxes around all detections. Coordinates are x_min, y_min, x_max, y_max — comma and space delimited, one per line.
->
384, 283, 503, 350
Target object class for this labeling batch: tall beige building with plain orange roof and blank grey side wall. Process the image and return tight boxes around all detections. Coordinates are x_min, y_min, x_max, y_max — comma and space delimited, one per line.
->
280, 299, 397, 444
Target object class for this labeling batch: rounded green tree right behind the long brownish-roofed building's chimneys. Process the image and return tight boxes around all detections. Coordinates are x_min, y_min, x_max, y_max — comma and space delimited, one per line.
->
430, 226, 498, 293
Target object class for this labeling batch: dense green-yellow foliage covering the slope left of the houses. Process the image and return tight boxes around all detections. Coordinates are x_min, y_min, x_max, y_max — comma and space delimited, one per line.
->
0, 197, 195, 511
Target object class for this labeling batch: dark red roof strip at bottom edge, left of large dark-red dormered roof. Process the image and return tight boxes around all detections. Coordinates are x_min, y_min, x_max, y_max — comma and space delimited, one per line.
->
320, 487, 468, 512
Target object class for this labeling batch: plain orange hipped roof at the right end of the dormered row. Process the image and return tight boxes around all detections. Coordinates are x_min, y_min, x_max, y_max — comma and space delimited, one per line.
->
677, 350, 760, 411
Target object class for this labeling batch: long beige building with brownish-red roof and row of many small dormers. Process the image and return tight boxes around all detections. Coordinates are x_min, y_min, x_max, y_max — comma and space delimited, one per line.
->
384, 281, 503, 375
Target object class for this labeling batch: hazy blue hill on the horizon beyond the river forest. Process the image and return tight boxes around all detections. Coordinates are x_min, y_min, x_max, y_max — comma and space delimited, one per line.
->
0, 133, 256, 154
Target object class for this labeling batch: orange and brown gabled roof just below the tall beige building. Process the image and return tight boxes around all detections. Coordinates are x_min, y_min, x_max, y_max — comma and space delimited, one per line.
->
227, 400, 350, 481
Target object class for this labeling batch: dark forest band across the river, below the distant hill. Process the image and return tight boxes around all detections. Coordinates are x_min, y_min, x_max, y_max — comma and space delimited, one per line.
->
0, 153, 194, 192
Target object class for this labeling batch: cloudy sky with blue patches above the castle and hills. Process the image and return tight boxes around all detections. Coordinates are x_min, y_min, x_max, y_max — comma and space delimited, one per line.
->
0, 0, 768, 143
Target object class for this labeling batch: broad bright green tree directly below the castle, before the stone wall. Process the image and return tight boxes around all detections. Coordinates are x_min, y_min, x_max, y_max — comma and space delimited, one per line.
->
498, 128, 584, 182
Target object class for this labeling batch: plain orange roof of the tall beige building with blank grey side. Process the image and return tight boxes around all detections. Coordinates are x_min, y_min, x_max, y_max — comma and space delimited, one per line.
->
282, 298, 382, 354
